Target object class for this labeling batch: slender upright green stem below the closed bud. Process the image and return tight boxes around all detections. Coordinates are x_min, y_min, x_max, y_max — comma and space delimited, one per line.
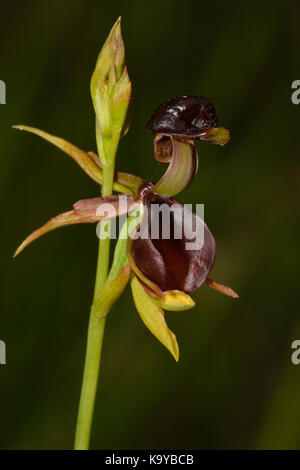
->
74, 130, 120, 450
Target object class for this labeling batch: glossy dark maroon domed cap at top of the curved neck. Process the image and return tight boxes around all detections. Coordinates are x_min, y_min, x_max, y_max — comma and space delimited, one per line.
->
147, 96, 218, 138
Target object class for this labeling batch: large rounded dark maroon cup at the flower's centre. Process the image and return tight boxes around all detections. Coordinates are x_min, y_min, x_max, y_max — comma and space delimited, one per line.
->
132, 186, 216, 293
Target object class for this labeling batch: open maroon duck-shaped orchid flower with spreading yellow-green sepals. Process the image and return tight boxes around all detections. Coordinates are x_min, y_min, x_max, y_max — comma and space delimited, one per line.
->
15, 92, 238, 360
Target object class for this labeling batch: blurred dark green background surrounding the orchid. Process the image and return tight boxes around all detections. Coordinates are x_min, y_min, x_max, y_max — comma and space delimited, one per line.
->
0, 0, 300, 449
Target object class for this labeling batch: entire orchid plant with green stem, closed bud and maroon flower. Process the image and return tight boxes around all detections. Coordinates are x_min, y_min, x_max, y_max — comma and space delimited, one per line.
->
14, 19, 238, 449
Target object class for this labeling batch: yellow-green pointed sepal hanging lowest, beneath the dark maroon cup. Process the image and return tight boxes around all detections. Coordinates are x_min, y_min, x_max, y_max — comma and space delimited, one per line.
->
131, 276, 179, 361
